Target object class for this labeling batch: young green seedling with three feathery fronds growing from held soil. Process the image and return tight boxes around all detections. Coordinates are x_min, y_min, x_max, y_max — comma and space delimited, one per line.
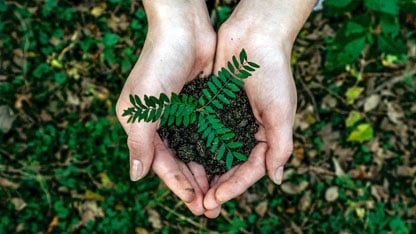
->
123, 49, 260, 169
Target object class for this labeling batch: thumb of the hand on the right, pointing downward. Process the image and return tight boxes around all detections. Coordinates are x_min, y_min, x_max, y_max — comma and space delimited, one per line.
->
265, 106, 294, 184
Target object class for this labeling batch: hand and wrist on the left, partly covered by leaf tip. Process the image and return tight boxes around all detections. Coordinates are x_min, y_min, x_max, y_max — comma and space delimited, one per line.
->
116, 0, 216, 215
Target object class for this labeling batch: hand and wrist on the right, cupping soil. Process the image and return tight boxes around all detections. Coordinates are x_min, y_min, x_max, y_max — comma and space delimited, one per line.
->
204, 0, 314, 218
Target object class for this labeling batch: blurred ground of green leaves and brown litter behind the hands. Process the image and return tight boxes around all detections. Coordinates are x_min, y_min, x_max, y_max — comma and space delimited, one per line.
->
0, 0, 416, 234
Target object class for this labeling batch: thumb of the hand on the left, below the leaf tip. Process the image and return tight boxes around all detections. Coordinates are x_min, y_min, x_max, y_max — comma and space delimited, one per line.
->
127, 123, 156, 181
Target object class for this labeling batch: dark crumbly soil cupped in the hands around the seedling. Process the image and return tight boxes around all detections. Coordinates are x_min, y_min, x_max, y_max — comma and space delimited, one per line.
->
159, 79, 257, 175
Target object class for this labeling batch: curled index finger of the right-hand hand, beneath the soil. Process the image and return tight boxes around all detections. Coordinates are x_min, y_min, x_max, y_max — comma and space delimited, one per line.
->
204, 143, 267, 209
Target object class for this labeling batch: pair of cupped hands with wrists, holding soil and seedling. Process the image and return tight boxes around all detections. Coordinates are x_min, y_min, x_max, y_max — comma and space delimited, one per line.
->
116, 0, 307, 218
